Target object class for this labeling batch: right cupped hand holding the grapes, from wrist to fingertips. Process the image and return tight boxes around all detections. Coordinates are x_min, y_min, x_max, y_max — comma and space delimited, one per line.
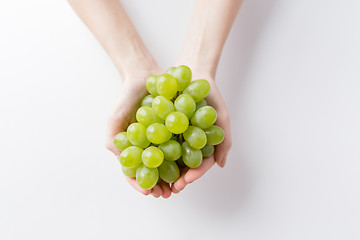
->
171, 71, 232, 193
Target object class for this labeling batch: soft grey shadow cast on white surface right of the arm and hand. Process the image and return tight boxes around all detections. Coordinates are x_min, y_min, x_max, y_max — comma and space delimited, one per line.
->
178, 0, 275, 217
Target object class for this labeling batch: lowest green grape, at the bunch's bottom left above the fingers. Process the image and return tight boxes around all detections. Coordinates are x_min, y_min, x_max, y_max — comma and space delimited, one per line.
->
136, 164, 159, 189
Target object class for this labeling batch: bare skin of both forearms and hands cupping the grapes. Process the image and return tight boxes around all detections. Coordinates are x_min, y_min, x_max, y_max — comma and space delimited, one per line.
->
68, 0, 241, 198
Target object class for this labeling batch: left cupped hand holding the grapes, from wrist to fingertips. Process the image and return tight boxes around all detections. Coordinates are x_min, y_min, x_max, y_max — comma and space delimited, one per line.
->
106, 70, 171, 198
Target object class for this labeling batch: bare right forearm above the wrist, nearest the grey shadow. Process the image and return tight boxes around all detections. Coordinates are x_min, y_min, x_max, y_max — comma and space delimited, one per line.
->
178, 0, 242, 76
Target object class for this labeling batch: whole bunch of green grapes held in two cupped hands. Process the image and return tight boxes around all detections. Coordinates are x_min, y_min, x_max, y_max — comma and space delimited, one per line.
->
114, 65, 225, 189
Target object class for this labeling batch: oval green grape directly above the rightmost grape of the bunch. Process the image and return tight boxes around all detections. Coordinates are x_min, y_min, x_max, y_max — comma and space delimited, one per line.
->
191, 106, 217, 129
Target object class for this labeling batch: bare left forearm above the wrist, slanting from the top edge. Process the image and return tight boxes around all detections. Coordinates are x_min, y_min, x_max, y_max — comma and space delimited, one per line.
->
68, 0, 158, 79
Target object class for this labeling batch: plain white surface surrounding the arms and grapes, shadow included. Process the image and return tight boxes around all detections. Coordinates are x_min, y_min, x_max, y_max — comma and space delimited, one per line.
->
0, 0, 360, 240
